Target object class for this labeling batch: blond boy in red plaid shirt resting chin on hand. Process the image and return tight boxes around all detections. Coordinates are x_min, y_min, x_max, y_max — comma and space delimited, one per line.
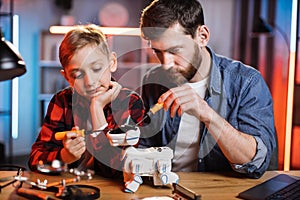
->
28, 25, 144, 177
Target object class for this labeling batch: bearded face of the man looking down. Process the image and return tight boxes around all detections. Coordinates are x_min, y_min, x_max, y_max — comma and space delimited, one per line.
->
151, 24, 201, 85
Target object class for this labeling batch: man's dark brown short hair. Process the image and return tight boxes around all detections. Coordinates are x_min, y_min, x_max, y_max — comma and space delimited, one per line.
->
140, 0, 204, 40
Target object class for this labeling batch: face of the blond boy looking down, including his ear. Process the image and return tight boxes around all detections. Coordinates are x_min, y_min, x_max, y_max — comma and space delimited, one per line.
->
62, 45, 117, 99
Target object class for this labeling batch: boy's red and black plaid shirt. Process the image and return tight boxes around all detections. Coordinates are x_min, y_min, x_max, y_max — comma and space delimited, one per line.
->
28, 87, 144, 177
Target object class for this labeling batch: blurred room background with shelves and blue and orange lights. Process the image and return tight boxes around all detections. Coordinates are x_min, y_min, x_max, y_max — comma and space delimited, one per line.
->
0, 0, 300, 169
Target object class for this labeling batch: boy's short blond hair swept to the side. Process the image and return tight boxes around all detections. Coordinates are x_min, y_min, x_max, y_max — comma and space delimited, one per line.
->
59, 24, 110, 68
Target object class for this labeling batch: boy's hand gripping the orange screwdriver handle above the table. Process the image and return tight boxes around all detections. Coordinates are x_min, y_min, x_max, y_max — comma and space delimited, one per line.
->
61, 127, 86, 164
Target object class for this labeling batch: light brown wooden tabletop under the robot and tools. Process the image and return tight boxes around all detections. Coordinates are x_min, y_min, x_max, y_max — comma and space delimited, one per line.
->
0, 171, 300, 200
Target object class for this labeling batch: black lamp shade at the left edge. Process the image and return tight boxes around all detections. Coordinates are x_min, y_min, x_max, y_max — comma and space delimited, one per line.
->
0, 33, 26, 81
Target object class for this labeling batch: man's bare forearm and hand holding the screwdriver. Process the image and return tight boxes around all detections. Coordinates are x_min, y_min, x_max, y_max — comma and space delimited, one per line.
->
158, 85, 256, 164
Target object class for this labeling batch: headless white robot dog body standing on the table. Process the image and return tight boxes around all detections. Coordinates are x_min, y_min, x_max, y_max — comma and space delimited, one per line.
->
123, 147, 179, 192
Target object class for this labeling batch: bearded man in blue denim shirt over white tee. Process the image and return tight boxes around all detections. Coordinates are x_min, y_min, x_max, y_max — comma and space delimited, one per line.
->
140, 0, 276, 178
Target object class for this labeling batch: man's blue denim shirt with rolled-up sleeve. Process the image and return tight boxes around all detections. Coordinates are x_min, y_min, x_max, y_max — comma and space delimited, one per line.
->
139, 47, 276, 178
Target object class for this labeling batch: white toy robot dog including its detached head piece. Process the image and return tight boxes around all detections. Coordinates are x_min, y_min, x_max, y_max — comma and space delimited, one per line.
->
106, 124, 179, 192
